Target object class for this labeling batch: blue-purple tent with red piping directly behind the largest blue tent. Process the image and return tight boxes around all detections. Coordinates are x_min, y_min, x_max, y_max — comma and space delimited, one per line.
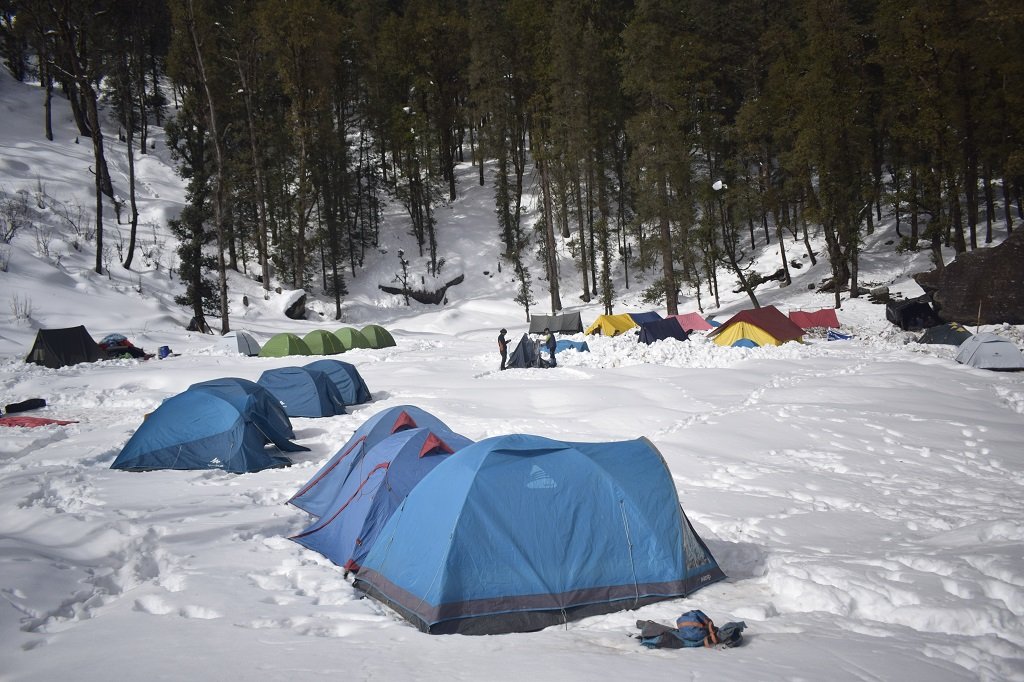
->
292, 428, 472, 570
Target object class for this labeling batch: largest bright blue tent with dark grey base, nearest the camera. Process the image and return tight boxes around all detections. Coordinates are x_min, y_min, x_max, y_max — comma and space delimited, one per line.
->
354, 434, 724, 634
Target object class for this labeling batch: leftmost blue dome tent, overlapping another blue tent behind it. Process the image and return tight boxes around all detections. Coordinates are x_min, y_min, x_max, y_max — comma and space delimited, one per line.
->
111, 390, 296, 473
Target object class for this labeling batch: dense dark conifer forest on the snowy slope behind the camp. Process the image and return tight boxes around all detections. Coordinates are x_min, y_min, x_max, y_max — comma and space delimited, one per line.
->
0, 0, 1024, 329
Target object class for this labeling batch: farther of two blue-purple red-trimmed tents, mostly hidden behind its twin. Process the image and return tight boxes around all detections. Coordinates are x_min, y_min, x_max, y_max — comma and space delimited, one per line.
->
288, 404, 451, 509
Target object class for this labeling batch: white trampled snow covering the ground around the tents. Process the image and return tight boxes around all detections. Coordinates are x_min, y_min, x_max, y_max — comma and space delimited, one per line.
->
0, 65, 1024, 681
